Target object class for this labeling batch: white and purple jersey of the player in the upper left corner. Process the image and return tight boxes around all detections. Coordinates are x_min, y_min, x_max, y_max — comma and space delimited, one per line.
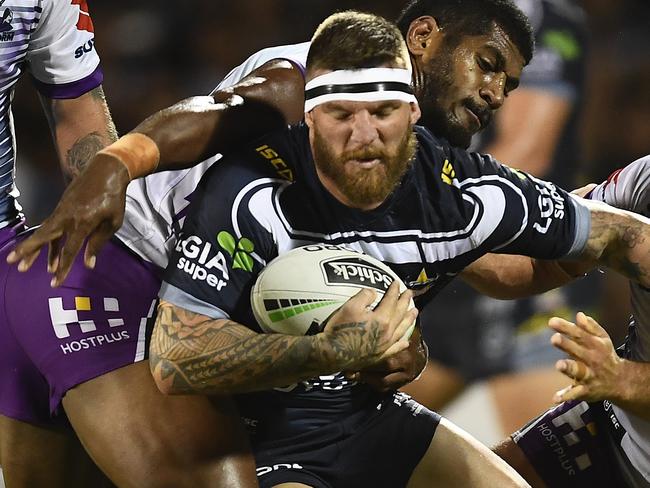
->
0, 0, 102, 228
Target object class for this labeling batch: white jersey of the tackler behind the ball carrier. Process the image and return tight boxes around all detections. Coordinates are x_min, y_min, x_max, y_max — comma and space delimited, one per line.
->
117, 42, 309, 269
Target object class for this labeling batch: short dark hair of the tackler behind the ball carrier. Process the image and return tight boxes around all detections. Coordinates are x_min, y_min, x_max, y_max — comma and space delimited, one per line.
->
397, 0, 535, 64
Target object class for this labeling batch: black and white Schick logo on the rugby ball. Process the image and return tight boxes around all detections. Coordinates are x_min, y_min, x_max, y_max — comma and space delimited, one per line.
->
321, 258, 393, 292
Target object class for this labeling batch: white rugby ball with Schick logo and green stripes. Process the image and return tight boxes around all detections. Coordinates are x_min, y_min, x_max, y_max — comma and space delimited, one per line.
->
251, 244, 415, 337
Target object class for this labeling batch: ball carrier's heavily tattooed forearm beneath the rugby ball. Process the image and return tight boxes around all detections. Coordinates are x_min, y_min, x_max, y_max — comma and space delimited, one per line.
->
150, 302, 377, 394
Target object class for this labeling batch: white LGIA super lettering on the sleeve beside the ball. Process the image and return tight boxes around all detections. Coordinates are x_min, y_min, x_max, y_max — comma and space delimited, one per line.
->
175, 236, 229, 290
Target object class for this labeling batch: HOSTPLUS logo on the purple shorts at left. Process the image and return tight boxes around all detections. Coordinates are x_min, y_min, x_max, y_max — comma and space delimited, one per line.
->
48, 296, 129, 354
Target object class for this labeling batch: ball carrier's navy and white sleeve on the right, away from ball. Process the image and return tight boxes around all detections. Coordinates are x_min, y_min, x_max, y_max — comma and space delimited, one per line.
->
443, 145, 591, 259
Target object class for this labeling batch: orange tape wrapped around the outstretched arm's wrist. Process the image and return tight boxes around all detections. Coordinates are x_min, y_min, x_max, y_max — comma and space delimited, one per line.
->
97, 132, 160, 180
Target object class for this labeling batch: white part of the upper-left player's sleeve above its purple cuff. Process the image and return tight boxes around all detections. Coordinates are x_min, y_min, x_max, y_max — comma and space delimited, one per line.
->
27, 0, 99, 85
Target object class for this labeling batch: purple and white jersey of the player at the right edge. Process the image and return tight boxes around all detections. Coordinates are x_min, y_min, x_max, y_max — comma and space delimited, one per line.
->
589, 156, 650, 482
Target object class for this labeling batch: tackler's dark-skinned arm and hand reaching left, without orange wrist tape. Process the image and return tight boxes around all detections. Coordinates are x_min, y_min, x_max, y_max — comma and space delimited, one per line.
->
7, 60, 304, 286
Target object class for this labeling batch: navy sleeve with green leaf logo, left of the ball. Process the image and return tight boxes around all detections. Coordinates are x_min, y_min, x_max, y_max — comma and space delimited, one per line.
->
160, 159, 286, 326
